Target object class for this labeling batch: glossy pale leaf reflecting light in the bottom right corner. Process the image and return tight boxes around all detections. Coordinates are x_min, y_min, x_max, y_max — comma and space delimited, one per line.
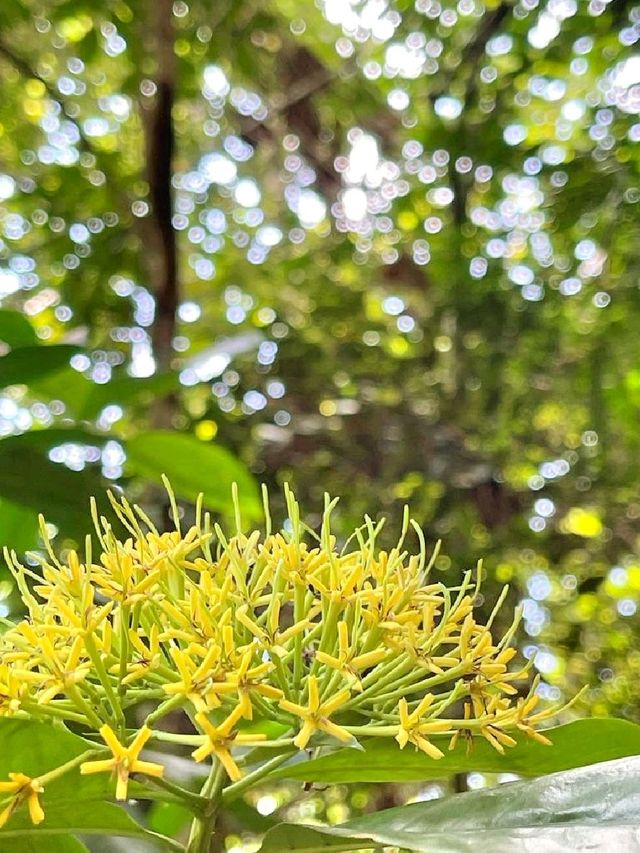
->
261, 757, 640, 853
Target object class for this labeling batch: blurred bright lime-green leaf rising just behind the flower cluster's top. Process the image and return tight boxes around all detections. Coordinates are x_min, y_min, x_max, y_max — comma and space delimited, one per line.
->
126, 430, 262, 520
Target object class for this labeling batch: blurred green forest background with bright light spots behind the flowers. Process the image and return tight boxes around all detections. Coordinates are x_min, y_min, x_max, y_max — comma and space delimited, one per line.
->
0, 0, 640, 800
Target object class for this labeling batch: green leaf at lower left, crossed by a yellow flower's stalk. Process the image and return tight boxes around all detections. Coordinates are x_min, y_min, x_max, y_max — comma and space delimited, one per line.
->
0, 717, 166, 853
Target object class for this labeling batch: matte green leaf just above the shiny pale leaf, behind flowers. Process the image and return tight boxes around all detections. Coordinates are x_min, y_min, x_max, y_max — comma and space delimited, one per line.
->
272, 719, 640, 783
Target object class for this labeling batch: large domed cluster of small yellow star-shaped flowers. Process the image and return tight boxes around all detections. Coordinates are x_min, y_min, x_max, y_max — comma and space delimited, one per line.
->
0, 490, 568, 824
